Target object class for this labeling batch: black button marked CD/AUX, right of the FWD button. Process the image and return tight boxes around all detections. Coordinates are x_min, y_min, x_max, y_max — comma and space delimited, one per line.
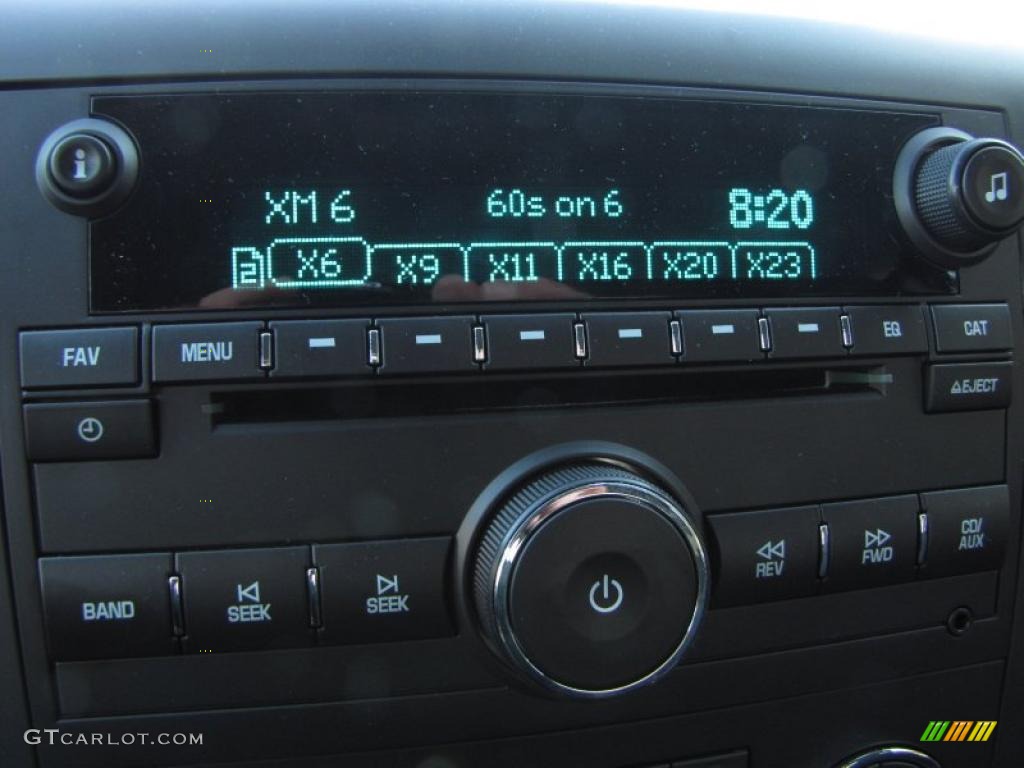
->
921, 485, 1010, 577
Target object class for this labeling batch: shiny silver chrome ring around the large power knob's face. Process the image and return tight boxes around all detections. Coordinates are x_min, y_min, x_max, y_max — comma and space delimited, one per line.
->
492, 479, 711, 698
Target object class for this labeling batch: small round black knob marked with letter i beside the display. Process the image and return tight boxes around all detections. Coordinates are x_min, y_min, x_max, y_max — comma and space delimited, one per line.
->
36, 119, 138, 217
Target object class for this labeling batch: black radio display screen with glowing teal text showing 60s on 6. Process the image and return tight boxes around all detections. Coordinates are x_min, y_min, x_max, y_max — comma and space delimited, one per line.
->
90, 91, 956, 312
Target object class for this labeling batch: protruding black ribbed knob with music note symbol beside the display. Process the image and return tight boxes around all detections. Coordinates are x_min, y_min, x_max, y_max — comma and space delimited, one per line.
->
894, 128, 1024, 268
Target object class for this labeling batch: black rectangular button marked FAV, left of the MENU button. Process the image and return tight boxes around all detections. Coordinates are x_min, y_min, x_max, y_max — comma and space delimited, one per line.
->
18, 328, 138, 389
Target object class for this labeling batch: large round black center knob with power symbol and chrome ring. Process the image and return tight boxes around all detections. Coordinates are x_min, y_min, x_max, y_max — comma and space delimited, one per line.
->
473, 462, 709, 697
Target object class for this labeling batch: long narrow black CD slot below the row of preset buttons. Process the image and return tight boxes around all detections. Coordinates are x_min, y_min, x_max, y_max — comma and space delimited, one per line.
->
207, 367, 892, 426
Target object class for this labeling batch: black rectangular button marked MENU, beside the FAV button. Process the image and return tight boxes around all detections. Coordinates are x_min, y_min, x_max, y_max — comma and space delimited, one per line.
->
153, 323, 263, 382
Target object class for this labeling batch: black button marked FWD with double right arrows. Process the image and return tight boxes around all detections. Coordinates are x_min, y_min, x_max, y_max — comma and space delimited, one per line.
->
821, 496, 919, 590
